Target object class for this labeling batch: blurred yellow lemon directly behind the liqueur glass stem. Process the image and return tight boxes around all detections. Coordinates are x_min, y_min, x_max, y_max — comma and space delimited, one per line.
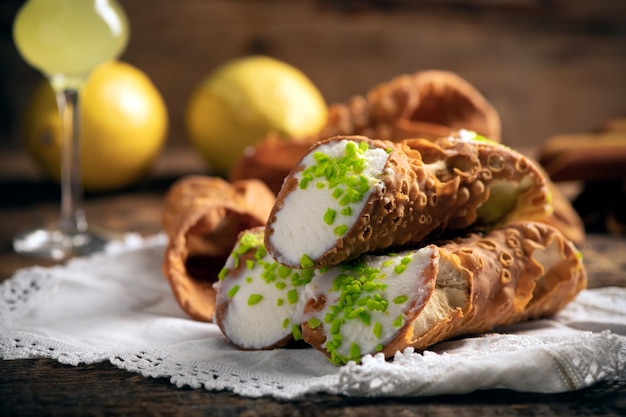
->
23, 61, 169, 191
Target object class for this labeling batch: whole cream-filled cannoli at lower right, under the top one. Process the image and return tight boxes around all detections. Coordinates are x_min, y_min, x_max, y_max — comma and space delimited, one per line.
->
302, 222, 586, 364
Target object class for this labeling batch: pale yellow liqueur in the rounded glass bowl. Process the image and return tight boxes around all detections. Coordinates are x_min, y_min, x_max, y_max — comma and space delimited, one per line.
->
13, 0, 129, 88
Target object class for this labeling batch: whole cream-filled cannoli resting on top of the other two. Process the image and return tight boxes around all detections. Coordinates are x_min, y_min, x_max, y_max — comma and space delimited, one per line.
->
265, 131, 551, 268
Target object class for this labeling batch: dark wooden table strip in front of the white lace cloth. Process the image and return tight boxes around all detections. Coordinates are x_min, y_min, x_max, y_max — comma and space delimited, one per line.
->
0, 359, 626, 417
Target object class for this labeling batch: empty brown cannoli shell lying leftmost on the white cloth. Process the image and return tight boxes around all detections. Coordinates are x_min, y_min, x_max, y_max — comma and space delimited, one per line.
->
162, 176, 274, 321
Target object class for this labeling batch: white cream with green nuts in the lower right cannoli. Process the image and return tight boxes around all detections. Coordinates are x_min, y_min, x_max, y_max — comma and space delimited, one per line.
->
302, 246, 438, 364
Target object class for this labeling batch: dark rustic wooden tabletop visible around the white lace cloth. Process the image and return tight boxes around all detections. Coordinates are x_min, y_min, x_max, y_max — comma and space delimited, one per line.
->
0, 148, 626, 417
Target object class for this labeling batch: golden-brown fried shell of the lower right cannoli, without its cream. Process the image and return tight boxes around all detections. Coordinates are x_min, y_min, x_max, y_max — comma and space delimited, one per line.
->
404, 222, 587, 354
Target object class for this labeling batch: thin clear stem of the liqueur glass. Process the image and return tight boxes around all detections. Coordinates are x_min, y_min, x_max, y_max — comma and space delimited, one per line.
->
56, 88, 87, 235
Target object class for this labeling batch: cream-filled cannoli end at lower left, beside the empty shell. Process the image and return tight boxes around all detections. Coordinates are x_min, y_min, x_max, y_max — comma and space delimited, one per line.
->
214, 227, 315, 350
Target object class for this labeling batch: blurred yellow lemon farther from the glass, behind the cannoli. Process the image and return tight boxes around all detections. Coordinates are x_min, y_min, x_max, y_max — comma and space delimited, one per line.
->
185, 56, 328, 174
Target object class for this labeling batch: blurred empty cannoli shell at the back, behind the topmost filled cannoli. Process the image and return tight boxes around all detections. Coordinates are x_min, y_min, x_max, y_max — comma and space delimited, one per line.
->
319, 70, 501, 142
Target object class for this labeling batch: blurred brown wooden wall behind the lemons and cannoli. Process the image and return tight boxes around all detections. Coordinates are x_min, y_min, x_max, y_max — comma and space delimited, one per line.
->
0, 0, 626, 158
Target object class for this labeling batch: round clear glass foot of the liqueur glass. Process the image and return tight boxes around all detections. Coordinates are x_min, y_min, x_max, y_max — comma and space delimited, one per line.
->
13, 226, 109, 260
